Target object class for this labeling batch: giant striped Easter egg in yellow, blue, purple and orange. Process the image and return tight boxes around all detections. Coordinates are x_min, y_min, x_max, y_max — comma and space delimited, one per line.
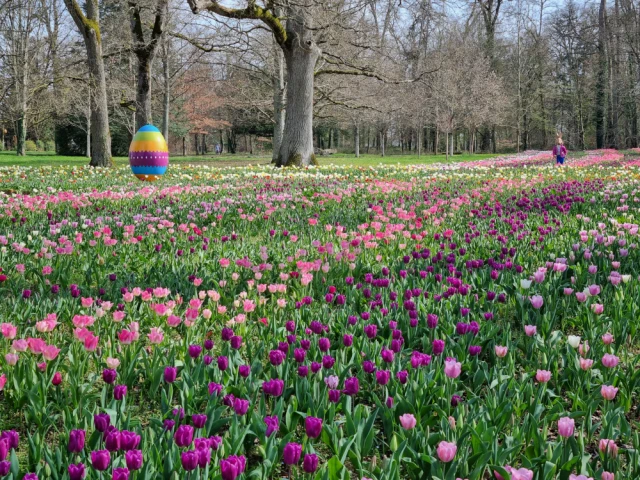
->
129, 125, 169, 182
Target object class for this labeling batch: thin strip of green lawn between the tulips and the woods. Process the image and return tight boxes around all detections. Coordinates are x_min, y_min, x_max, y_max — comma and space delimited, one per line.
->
0, 151, 495, 167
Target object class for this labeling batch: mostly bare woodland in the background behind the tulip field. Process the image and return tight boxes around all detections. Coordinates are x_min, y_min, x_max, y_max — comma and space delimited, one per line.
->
0, 0, 640, 164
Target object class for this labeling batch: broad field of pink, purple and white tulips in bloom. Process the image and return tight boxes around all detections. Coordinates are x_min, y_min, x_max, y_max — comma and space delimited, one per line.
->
0, 150, 640, 480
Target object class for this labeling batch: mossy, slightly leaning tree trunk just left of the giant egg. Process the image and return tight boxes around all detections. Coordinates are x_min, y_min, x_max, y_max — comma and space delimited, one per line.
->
64, 0, 113, 167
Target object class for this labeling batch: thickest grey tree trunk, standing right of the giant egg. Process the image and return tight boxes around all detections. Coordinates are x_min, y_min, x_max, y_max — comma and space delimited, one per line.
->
276, 6, 321, 167
